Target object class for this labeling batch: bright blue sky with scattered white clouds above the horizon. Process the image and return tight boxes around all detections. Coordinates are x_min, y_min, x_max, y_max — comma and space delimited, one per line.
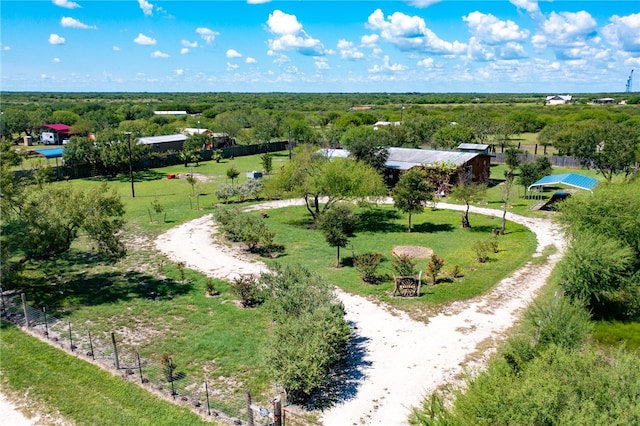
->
0, 0, 640, 94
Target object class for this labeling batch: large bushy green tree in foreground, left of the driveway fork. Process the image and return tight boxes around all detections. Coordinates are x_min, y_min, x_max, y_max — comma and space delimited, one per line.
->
258, 264, 350, 401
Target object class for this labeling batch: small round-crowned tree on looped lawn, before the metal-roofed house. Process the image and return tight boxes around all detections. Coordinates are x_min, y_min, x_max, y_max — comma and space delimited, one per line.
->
393, 168, 433, 232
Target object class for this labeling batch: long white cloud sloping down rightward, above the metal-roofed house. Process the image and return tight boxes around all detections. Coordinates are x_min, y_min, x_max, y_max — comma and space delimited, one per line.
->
367, 9, 467, 55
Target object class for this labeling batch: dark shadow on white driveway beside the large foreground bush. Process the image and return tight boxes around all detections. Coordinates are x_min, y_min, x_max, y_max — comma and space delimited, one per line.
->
302, 322, 371, 410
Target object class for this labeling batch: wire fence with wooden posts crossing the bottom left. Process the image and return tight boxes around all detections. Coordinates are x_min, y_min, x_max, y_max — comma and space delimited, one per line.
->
0, 288, 279, 426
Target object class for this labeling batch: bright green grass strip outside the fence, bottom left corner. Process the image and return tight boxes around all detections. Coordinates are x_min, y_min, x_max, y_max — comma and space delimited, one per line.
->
0, 322, 211, 426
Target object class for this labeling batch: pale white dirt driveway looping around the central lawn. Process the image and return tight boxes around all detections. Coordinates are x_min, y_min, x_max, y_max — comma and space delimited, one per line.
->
156, 200, 564, 426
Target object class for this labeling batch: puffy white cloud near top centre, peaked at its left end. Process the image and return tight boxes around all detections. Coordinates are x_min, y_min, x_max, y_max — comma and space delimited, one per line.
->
267, 10, 326, 56
